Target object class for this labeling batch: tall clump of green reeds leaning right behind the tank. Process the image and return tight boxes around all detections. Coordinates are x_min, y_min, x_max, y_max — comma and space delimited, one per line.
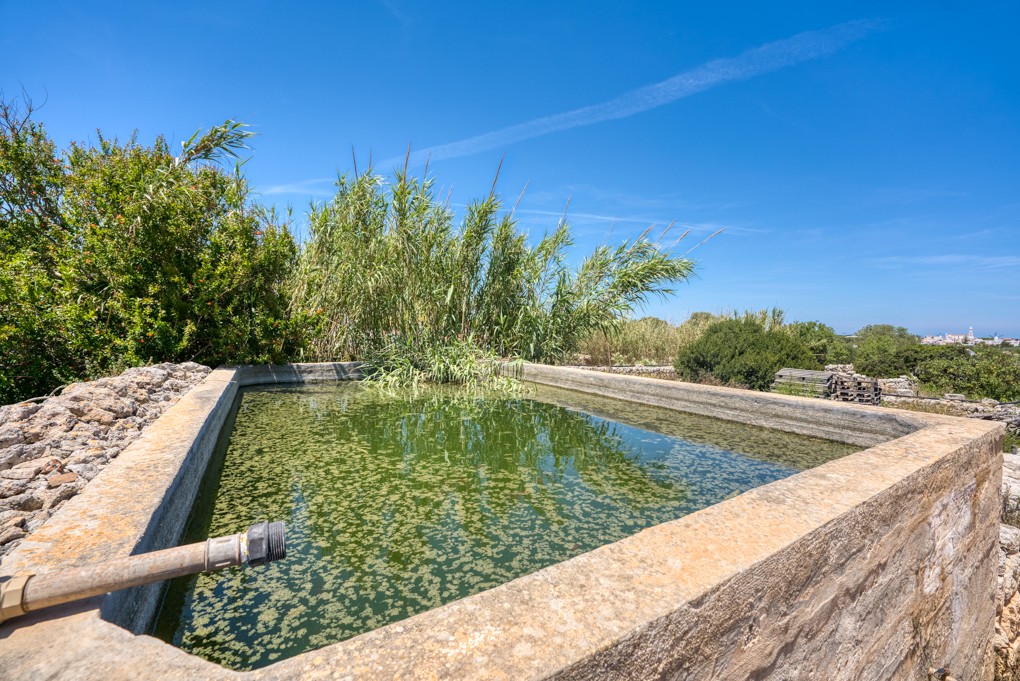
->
291, 168, 694, 382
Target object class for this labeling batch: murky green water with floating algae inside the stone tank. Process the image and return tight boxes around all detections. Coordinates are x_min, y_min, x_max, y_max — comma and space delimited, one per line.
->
154, 383, 859, 670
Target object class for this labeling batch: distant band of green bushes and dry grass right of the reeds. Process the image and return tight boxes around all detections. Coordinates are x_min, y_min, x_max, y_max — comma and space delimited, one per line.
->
581, 316, 1020, 402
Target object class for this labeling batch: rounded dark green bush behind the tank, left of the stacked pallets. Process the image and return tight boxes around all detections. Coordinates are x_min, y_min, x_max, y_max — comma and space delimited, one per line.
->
675, 315, 820, 390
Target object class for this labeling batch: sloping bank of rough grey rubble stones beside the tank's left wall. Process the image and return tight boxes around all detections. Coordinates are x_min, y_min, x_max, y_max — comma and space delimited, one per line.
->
0, 362, 211, 562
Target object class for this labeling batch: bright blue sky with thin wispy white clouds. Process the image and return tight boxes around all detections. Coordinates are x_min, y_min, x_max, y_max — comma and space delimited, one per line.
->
0, 0, 1020, 336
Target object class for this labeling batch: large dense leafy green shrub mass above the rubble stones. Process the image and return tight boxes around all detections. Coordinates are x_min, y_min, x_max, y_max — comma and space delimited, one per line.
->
0, 102, 300, 403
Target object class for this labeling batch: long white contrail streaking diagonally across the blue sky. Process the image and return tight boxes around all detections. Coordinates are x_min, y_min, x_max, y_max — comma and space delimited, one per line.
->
379, 20, 882, 167
